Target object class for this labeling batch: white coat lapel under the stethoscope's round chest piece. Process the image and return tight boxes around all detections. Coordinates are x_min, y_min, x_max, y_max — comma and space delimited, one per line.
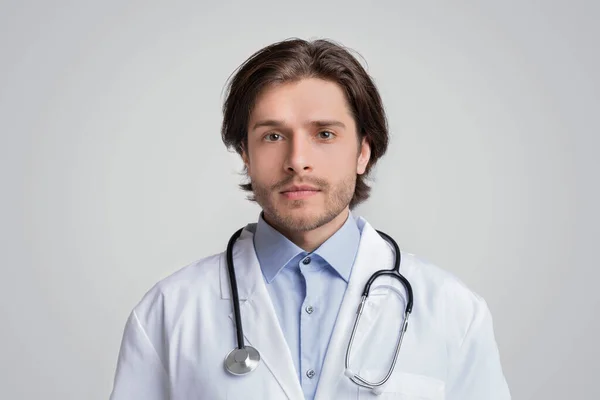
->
221, 231, 304, 400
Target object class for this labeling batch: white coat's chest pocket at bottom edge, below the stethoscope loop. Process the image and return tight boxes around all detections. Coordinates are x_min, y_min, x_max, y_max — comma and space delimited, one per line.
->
358, 370, 446, 400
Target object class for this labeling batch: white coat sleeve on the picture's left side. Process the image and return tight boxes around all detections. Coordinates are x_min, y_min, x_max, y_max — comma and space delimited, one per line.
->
110, 310, 169, 400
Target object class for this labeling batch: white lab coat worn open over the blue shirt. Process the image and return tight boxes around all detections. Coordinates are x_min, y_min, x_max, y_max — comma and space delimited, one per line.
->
110, 218, 510, 400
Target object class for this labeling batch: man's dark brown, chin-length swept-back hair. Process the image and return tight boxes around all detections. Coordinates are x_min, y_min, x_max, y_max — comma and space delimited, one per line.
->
221, 38, 389, 208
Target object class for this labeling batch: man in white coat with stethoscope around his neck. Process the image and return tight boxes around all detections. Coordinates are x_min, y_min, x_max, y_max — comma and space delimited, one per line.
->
111, 40, 510, 400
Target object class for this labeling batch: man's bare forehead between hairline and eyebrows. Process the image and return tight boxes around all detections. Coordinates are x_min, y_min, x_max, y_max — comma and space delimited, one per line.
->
249, 78, 352, 123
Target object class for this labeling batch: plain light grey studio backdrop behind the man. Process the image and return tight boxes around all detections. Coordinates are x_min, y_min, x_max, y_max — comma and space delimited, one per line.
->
0, 1, 600, 400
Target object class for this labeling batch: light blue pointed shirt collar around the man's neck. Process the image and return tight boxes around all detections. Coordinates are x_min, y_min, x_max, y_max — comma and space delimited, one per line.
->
254, 212, 361, 283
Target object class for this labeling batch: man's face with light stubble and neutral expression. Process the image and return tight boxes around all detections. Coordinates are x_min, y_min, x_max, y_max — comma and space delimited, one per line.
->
242, 78, 370, 232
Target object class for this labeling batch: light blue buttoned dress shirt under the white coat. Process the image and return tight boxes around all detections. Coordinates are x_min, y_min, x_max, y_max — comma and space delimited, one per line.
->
254, 213, 361, 399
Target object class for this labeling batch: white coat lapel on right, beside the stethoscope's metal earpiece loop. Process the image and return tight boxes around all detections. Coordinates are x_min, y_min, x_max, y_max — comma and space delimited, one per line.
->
315, 218, 394, 400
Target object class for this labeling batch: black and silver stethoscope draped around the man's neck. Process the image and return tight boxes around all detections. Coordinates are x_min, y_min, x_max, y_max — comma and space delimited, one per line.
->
225, 228, 413, 391
